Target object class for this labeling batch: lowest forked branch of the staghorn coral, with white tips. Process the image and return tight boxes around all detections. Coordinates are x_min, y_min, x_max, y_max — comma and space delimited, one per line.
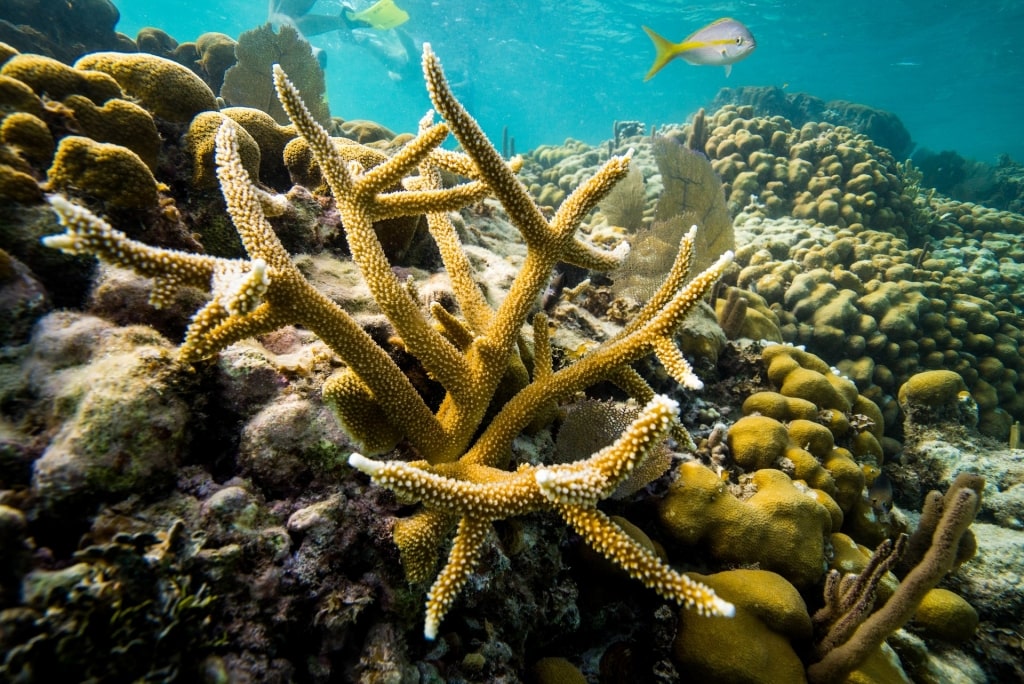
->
349, 396, 733, 639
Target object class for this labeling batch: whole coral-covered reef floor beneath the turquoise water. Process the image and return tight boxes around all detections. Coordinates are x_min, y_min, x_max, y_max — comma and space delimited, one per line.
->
0, 0, 1024, 683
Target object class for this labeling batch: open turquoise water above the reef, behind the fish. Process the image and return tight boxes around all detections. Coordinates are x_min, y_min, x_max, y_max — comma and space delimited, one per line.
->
96, 0, 1024, 162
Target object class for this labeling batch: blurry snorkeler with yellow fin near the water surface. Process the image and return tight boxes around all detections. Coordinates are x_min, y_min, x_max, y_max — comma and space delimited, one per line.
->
269, 0, 419, 80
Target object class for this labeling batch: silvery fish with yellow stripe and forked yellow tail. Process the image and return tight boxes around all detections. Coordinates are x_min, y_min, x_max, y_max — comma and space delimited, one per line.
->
642, 17, 757, 81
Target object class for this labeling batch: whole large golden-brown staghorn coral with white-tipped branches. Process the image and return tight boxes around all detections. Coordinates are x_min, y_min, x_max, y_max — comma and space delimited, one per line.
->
44, 45, 733, 638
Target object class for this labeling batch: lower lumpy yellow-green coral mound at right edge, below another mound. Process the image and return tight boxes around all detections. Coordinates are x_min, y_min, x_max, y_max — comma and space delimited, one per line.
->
735, 217, 1024, 438
